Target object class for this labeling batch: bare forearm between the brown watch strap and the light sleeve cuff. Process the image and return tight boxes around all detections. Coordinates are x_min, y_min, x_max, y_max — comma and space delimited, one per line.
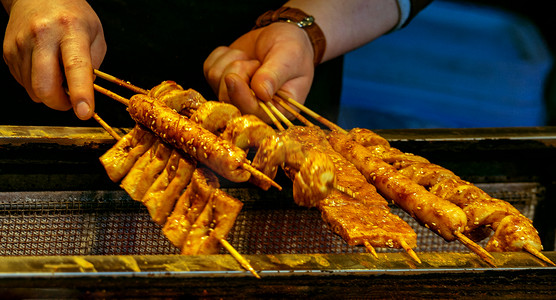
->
284, 0, 400, 61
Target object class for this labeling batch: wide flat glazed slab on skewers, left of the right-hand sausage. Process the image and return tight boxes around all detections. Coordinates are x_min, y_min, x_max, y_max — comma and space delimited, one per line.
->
283, 126, 417, 249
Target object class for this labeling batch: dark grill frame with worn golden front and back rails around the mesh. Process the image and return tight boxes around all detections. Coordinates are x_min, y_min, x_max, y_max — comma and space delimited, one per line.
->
0, 126, 556, 298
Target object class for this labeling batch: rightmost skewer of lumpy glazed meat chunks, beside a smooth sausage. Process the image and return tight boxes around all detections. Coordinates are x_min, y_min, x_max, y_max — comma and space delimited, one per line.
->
350, 129, 542, 252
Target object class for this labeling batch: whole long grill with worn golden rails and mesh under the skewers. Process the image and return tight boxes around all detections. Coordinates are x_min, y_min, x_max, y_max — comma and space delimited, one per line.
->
0, 126, 556, 298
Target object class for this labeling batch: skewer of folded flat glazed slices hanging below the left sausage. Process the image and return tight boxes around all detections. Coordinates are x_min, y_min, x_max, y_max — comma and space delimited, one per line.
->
97, 123, 243, 254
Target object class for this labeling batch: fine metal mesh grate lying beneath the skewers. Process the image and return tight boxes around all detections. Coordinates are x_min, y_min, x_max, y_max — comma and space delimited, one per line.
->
0, 183, 544, 256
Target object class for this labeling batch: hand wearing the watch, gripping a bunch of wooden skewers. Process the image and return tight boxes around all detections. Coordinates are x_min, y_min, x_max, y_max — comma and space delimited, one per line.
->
203, 23, 314, 122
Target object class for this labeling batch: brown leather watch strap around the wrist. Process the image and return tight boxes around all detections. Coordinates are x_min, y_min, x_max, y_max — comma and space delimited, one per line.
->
255, 7, 326, 66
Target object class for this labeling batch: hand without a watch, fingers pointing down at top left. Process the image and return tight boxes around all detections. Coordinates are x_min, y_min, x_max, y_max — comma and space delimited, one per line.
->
3, 0, 106, 120
